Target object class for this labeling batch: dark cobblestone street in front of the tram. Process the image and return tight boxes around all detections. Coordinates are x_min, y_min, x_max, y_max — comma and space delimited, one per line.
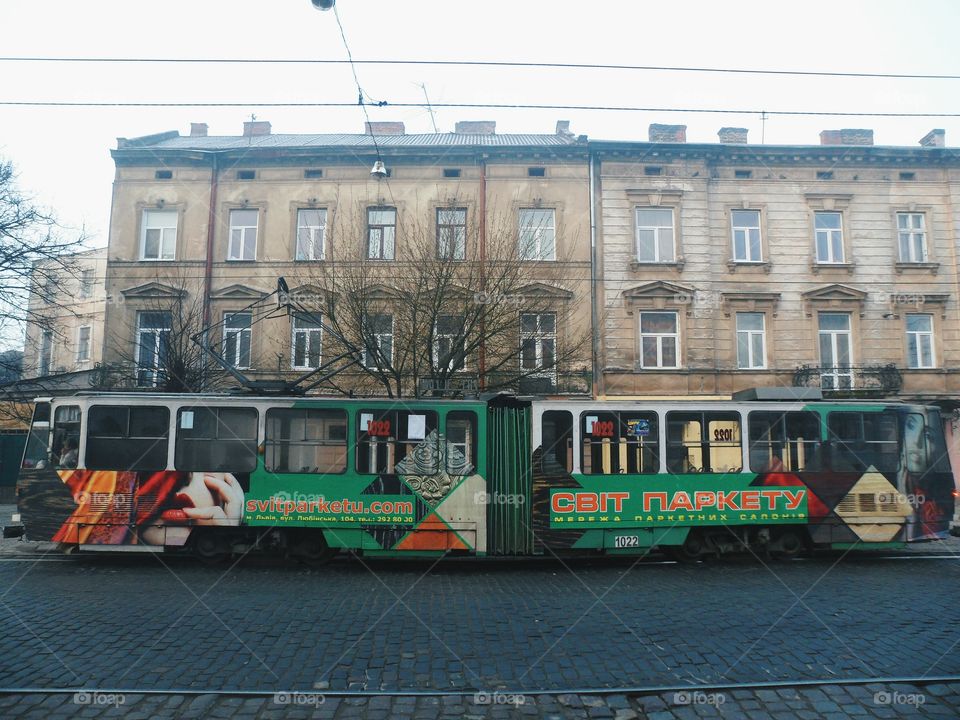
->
0, 520, 960, 718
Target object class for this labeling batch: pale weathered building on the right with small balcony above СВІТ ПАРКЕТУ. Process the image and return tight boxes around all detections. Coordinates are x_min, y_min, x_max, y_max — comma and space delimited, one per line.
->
590, 125, 960, 408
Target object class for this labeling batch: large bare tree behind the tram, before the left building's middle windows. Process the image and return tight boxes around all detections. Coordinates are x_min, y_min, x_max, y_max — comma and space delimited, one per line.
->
297, 202, 590, 397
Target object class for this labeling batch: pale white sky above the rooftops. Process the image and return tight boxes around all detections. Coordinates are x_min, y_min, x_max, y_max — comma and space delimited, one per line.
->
0, 0, 960, 246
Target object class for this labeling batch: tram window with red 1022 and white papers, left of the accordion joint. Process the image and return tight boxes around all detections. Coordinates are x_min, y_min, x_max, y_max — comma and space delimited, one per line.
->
357, 410, 440, 475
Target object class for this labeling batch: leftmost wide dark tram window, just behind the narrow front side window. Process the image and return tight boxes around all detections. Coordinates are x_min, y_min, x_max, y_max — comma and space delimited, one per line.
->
86, 405, 170, 470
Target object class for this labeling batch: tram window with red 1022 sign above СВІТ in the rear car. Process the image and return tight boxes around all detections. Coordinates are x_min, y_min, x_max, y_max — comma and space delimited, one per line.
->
580, 412, 660, 475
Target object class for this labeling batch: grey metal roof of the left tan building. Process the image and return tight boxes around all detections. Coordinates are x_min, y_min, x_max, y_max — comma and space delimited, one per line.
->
124, 133, 577, 150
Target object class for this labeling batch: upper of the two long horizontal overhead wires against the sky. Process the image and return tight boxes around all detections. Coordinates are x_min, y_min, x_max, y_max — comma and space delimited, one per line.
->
0, 56, 960, 80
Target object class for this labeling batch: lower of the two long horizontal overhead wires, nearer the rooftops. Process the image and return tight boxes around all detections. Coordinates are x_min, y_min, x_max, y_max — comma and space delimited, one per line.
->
0, 100, 960, 118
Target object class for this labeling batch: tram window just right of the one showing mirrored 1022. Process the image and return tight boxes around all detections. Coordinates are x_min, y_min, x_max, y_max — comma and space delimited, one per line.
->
749, 412, 820, 472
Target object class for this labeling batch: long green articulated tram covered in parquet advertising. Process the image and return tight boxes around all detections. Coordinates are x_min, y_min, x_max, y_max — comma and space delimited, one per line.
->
11, 391, 955, 562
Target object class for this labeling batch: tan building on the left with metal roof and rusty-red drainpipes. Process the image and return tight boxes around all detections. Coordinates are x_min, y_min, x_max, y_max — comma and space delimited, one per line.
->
104, 121, 591, 394
